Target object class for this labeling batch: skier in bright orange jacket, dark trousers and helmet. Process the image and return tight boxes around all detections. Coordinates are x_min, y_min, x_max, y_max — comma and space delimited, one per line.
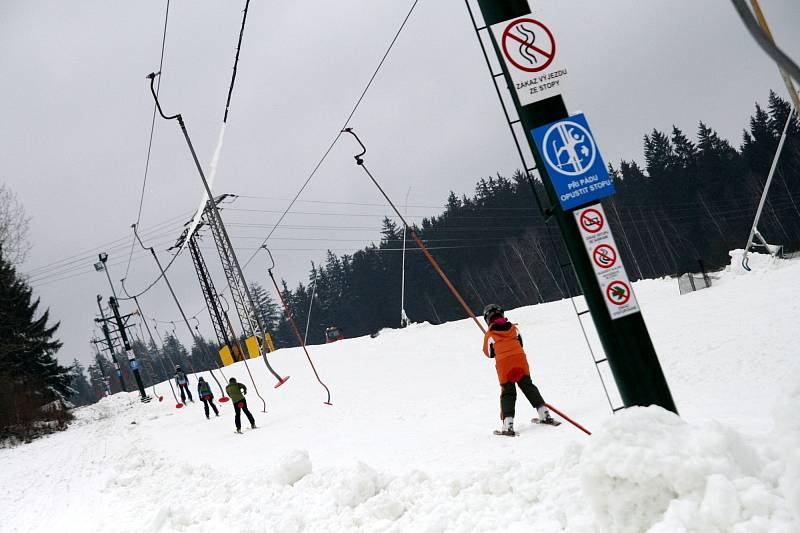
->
483, 304, 559, 436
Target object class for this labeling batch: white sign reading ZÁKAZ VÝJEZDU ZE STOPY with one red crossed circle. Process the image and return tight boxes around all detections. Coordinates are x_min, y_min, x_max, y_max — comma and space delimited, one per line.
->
492, 15, 567, 106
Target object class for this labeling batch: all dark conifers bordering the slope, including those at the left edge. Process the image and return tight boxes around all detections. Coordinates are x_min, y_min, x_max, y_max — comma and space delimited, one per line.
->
0, 93, 800, 424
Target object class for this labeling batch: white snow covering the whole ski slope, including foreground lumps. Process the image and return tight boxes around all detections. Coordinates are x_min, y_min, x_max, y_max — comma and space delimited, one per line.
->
0, 252, 800, 533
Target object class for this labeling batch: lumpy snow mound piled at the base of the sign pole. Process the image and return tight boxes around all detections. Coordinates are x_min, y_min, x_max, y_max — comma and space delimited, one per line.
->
580, 376, 800, 532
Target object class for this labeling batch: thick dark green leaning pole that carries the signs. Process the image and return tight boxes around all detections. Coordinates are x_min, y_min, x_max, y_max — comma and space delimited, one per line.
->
476, 0, 678, 413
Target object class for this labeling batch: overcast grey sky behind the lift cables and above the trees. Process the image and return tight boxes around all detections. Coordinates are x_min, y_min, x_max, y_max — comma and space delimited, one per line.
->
0, 0, 800, 362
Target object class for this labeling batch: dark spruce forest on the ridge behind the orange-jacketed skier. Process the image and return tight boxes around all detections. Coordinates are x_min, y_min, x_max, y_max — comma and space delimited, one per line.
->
257, 93, 800, 347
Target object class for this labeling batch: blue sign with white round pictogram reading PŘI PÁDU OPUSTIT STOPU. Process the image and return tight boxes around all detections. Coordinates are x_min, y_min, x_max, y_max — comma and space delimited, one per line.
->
531, 113, 615, 209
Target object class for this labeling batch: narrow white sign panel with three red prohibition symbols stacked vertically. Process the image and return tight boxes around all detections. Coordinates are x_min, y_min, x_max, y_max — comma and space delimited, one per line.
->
574, 203, 639, 320
